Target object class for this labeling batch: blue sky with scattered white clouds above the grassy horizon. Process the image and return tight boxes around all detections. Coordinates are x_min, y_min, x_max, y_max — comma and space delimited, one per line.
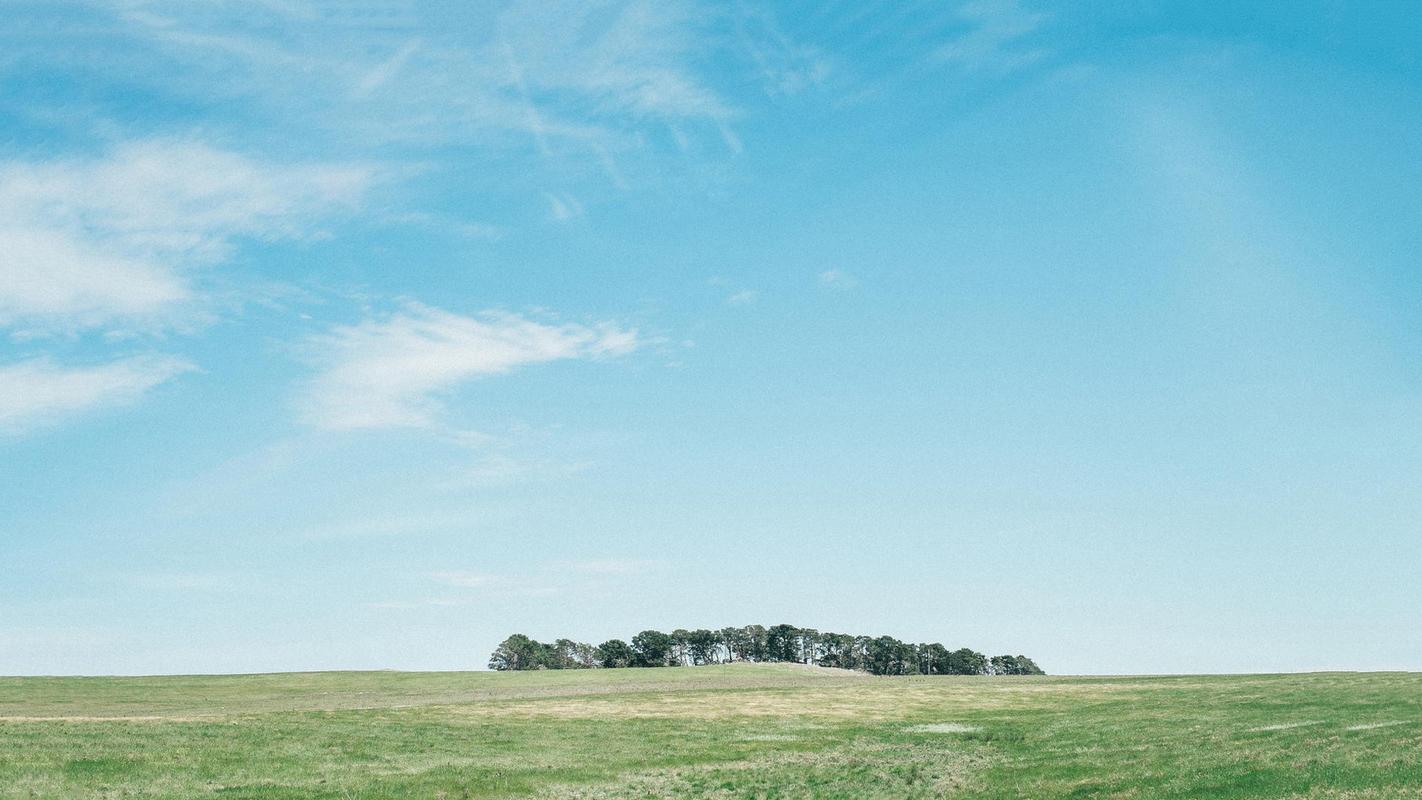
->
0, 0, 1422, 674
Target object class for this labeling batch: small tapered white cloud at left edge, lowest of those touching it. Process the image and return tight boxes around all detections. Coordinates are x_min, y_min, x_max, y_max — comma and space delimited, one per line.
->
0, 355, 193, 432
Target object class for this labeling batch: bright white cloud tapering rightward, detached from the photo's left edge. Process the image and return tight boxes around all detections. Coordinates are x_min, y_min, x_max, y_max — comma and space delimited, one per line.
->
299, 303, 637, 429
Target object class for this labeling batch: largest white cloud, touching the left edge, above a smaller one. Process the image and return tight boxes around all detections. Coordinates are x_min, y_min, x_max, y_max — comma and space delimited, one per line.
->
0, 139, 373, 330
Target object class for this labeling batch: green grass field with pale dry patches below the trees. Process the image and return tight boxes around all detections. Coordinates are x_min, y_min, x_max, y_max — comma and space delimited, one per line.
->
0, 665, 1422, 800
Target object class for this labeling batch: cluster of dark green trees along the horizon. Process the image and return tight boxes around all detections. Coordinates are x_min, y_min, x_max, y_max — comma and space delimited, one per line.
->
489, 625, 1045, 675
